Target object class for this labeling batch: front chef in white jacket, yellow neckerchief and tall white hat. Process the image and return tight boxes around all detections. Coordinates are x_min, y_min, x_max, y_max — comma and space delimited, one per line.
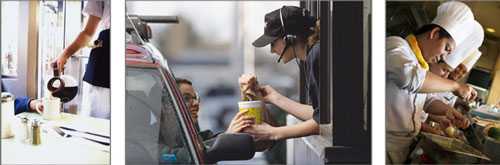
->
386, 1, 476, 163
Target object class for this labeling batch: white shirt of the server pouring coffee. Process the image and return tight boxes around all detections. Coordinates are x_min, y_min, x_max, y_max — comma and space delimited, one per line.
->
83, 0, 111, 30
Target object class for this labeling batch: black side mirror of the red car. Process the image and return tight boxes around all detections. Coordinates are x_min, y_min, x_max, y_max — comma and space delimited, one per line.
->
207, 133, 255, 163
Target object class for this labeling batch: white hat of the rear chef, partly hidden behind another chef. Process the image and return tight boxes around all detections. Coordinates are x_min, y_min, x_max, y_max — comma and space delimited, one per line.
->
444, 20, 484, 69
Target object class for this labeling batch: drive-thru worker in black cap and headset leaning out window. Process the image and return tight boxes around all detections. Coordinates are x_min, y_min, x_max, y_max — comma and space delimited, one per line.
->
240, 6, 320, 140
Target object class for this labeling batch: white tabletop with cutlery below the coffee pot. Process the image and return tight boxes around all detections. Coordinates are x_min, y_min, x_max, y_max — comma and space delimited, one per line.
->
1, 113, 110, 164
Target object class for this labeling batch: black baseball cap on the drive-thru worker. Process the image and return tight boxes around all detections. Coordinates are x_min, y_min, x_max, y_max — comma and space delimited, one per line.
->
252, 6, 314, 47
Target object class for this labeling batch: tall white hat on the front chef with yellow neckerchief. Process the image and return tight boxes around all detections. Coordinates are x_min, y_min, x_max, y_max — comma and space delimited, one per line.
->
432, 1, 474, 45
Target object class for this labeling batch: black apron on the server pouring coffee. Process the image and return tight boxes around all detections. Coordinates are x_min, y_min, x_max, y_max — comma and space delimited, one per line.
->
83, 29, 110, 88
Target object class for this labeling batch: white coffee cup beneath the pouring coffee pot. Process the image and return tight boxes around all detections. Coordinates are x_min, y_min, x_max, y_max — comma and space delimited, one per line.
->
36, 97, 61, 120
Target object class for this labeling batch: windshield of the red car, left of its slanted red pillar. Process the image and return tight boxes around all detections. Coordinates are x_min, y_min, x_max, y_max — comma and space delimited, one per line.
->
125, 68, 194, 164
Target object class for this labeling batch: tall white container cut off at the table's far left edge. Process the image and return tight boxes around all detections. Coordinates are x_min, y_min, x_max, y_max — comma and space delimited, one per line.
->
1, 92, 15, 139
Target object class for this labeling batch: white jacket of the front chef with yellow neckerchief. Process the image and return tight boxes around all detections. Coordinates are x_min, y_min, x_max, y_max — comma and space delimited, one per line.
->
386, 36, 430, 137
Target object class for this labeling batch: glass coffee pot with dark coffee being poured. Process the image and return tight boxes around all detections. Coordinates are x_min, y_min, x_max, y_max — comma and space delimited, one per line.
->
47, 63, 78, 103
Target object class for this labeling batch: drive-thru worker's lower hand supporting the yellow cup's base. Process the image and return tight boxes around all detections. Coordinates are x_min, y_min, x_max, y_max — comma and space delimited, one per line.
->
243, 122, 280, 141
